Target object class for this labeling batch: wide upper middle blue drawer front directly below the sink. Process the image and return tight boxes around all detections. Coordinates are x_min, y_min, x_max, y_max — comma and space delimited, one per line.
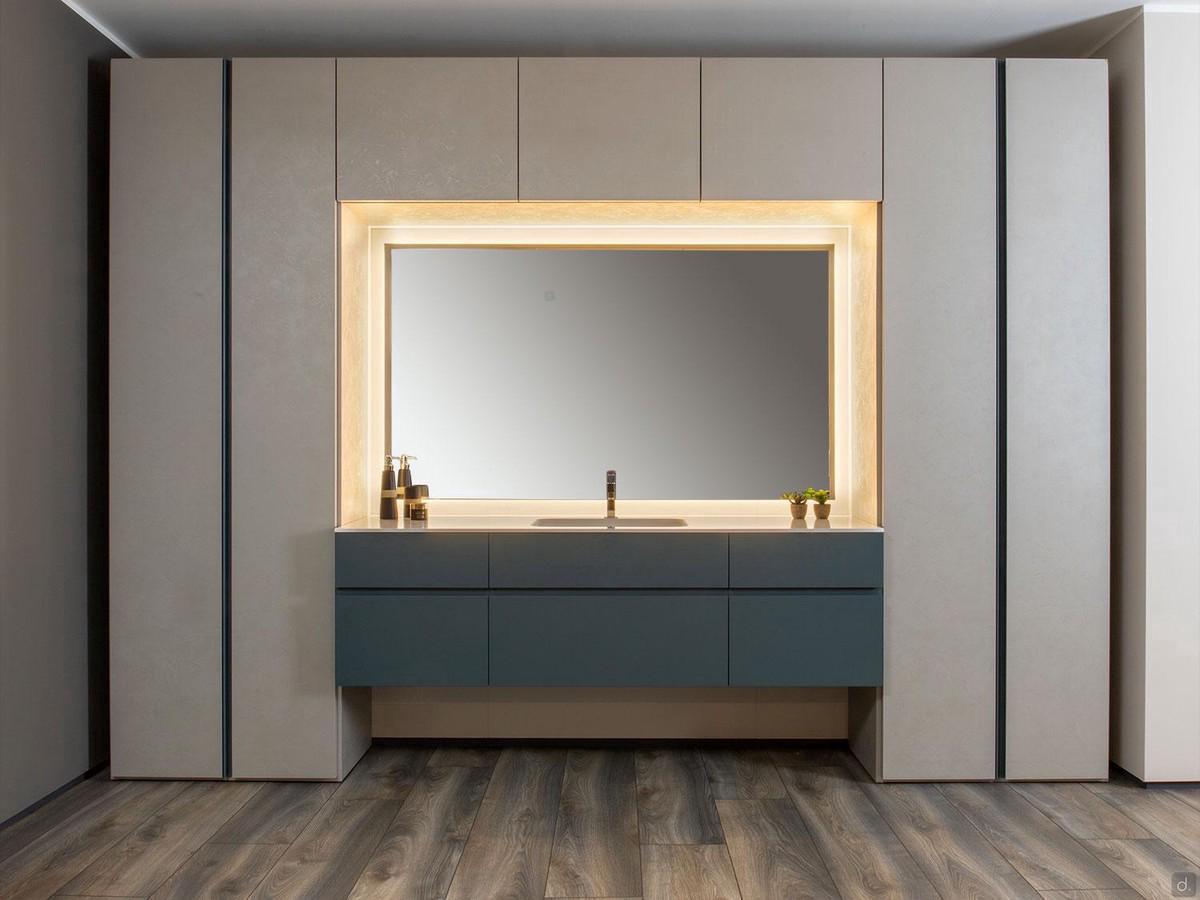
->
491, 532, 730, 588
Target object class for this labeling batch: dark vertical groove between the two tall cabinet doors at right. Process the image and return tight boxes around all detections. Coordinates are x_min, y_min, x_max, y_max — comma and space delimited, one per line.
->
996, 60, 1008, 780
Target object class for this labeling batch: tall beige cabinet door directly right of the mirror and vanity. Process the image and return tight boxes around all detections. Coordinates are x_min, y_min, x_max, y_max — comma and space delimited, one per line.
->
882, 59, 997, 780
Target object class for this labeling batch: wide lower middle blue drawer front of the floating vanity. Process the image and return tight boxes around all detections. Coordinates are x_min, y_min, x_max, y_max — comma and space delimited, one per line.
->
490, 590, 728, 686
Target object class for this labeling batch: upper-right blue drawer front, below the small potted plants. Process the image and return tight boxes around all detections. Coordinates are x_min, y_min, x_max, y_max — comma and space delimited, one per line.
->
730, 532, 883, 588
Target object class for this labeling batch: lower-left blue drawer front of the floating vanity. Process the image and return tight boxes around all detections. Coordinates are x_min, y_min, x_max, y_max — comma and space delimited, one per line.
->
336, 590, 487, 685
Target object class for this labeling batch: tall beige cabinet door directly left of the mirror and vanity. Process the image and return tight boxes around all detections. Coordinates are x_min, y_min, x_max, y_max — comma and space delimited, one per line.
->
230, 59, 338, 779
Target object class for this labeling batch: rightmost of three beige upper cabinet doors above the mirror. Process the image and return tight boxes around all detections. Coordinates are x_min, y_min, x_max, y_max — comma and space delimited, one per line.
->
701, 59, 883, 200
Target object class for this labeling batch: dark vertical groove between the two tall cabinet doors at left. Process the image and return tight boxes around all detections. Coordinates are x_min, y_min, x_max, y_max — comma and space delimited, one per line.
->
221, 60, 233, 778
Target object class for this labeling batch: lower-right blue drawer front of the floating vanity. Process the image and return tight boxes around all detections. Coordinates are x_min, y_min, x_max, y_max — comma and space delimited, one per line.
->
730, 590, 883, 686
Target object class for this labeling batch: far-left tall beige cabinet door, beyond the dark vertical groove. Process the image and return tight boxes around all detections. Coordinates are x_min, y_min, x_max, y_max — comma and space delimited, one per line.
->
109, 59, 223, 778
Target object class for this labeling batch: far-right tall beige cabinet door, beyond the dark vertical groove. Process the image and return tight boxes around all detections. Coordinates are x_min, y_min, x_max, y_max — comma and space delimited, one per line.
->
1006, 59, 1110, 779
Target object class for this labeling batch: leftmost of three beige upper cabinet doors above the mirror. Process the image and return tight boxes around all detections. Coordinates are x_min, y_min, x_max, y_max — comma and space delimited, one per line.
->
337, 59, 517, 200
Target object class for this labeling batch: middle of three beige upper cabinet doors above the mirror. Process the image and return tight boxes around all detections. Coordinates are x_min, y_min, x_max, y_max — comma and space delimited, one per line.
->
521, 59, 700, 200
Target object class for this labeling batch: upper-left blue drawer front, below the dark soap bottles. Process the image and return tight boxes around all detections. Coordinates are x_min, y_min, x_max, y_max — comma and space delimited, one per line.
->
334, 532, 487, 588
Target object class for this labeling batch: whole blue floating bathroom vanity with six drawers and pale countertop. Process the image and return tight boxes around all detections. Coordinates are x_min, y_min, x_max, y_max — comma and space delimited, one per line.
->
336, 516, 883, 688
